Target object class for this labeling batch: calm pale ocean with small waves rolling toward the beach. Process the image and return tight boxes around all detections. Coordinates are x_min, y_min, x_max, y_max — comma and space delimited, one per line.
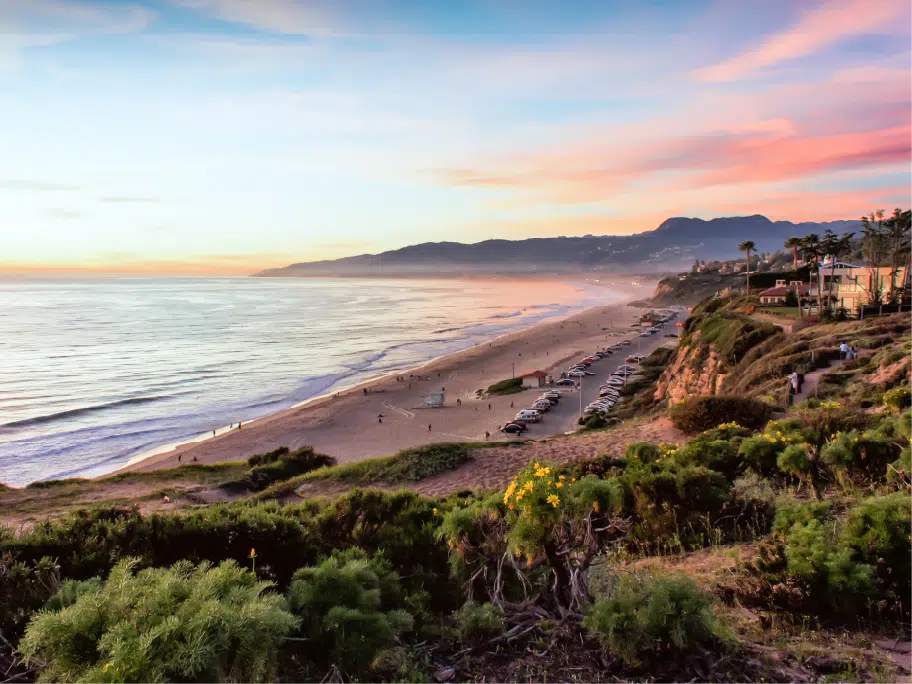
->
0, 278, 618, 486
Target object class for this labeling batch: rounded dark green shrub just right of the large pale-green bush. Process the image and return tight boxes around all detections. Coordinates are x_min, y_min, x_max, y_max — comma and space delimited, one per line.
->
288, 551, 413, 673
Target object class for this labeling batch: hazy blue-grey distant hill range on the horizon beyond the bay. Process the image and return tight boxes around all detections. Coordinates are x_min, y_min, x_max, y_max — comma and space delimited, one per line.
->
255, 215, 859, 277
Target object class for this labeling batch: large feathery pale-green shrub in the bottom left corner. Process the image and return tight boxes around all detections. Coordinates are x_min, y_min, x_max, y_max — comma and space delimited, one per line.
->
20, 560, 298, 683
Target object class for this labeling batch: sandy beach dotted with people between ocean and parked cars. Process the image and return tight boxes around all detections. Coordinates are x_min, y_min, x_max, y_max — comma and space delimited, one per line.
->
123, 282, 662, 470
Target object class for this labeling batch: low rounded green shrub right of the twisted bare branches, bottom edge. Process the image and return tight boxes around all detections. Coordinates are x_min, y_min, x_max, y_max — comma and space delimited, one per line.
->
583, 575, 724, 665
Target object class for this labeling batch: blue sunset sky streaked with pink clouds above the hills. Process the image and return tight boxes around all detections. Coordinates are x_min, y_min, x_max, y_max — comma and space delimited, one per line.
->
0, 0, 912, 275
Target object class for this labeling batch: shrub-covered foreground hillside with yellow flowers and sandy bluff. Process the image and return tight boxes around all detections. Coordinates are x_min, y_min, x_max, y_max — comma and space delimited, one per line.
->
0, 299, 912, 684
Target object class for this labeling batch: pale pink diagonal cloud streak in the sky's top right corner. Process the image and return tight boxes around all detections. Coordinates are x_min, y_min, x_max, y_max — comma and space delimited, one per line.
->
695, 0, 909, 82
